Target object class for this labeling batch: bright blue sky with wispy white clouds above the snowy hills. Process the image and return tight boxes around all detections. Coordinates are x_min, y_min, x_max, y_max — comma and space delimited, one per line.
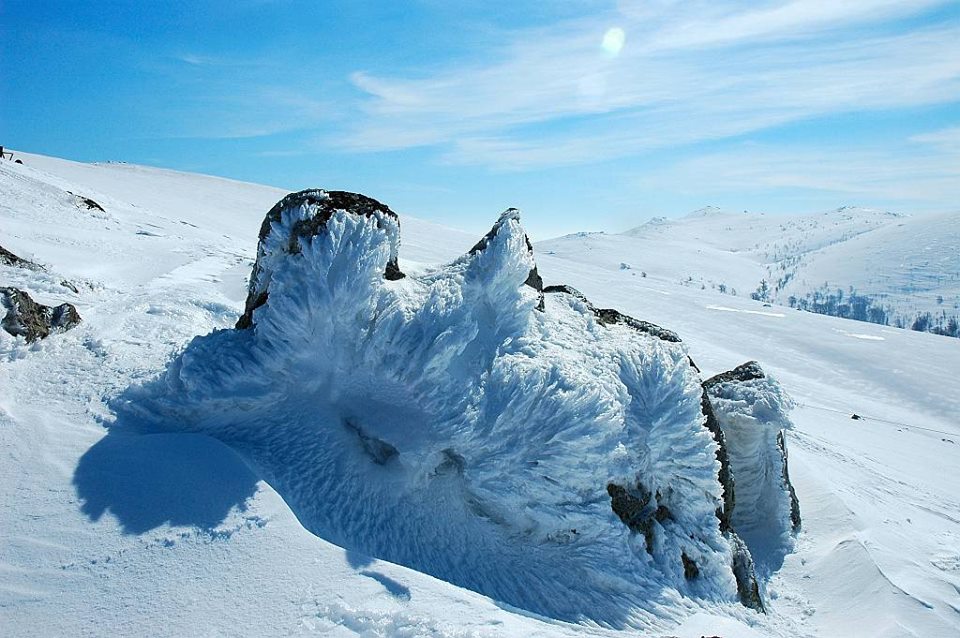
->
0, 0, 960, 239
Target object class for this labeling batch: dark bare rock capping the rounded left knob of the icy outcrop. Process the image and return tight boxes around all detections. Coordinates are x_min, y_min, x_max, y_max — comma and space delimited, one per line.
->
242, 189, 406, 329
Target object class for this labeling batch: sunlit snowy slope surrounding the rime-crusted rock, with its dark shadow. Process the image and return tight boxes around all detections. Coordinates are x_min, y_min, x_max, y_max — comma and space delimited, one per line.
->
0, 154, 960, 638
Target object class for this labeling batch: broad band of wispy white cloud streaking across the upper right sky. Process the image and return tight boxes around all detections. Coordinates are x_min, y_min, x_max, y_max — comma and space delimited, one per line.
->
341, 0, 960, 169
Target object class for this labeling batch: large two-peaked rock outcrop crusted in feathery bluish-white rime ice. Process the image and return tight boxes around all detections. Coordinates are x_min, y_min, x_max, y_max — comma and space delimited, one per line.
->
118, 190, 796, 626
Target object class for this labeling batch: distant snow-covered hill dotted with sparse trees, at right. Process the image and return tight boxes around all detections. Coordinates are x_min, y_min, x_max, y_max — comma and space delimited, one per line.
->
538, 207, 960, 336
